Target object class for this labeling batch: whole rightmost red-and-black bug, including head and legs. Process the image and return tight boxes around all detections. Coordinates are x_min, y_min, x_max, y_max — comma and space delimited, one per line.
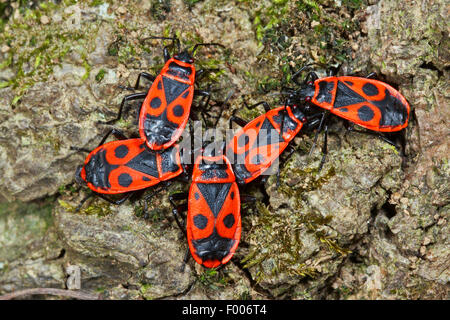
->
285, 65, 417, 170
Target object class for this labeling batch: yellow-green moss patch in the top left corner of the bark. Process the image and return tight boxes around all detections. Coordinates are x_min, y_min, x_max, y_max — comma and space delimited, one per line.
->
0, 2, 100, 106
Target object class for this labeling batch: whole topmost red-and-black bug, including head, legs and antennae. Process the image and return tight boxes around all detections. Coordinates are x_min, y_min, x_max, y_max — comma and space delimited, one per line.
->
100, 37, 223, 151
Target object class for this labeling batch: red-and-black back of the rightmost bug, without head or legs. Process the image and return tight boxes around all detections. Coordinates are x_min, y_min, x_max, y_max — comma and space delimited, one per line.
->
311, 76, 410, 132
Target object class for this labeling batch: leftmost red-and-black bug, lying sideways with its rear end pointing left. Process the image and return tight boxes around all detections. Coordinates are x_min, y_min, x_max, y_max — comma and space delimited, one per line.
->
74, 129, 184, 204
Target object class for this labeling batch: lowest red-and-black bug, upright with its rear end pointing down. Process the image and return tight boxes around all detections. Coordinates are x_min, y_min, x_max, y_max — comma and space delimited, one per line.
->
170, 155, 241, 268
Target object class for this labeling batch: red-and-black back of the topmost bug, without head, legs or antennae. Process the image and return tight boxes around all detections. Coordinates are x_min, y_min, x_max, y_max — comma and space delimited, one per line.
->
139, 58, 195, 150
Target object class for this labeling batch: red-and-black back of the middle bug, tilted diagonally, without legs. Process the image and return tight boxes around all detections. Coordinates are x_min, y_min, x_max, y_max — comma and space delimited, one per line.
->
226, 106, 303, 183
